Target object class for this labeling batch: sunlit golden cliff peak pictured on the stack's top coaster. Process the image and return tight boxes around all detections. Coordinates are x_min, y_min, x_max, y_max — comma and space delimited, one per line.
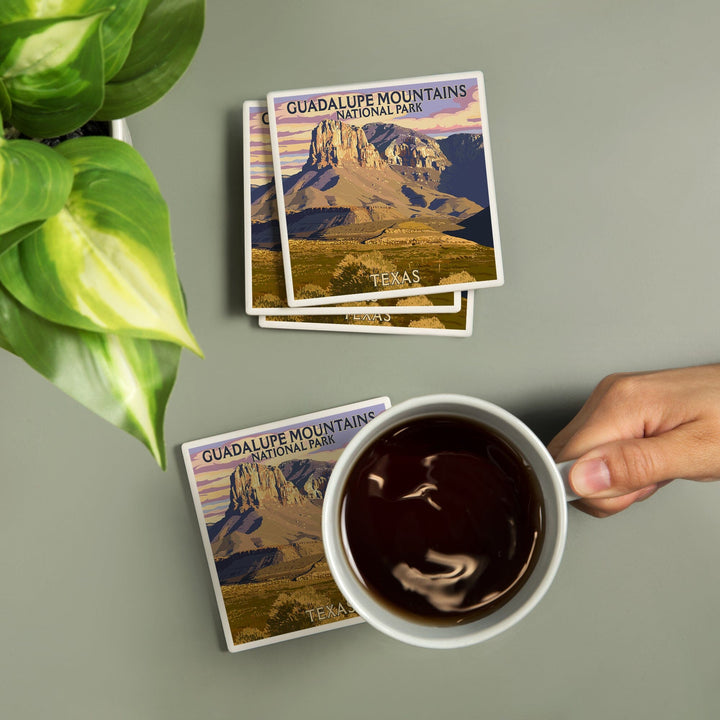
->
305, 120, 384, 170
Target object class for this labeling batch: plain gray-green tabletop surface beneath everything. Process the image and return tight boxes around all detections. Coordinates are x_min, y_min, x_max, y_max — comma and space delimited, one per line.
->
0, 0, 720, 720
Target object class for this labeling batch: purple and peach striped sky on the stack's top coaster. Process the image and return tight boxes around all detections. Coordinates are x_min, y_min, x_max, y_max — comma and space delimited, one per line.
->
274, 76, 483, 176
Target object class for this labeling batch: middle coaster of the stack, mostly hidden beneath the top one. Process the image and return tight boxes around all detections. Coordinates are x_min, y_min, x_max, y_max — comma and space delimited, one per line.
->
243, 100, 460, 316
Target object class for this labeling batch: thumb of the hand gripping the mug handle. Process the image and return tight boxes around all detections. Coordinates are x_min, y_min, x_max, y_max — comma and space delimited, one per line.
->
570, 428, 692, 498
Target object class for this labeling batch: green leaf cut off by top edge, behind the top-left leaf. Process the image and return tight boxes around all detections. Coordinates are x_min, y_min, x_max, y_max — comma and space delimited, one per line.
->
0, 0, 148, 80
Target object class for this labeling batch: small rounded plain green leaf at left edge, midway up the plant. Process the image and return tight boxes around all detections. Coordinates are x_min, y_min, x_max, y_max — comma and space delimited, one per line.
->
0, 137, 73, 233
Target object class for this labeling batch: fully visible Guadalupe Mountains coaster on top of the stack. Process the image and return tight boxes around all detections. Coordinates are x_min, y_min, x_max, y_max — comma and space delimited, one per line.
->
268, 72, 503, 307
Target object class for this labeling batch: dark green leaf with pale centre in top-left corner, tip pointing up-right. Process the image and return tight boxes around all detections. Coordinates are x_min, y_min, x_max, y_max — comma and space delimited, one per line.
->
0, 12, 107, 137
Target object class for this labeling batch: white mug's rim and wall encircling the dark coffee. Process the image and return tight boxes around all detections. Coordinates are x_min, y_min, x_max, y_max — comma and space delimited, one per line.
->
322, 394, 577, 648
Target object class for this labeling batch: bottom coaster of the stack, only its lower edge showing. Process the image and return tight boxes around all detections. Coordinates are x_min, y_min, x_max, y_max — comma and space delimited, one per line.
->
258, 293, 475, 337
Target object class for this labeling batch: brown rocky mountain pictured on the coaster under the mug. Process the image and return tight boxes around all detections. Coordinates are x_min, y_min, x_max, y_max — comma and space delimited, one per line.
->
208, 460, 332, 584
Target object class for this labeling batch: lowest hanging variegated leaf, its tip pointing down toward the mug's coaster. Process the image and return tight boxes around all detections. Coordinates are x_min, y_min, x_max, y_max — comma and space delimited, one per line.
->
0, 286, 180, 469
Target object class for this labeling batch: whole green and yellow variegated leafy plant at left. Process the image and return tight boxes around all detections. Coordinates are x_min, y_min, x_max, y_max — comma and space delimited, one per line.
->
0, 0, 204, 469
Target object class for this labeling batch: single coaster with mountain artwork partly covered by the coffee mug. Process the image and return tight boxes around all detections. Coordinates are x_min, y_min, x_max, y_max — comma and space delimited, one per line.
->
182, 397, 390, 652
